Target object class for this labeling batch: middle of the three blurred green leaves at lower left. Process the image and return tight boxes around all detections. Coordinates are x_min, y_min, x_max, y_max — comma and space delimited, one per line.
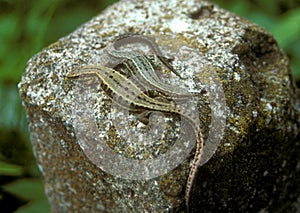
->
2, 178, 46, 200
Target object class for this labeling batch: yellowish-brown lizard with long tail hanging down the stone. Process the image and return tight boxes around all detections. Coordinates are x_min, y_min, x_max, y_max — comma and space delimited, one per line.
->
67, 65, 204, 208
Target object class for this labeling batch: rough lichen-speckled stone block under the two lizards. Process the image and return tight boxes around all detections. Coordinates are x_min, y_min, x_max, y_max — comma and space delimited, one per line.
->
19, 0, 300, 212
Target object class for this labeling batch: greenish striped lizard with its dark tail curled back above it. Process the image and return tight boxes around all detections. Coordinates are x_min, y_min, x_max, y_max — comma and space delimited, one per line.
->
106, 34, 202, 100
